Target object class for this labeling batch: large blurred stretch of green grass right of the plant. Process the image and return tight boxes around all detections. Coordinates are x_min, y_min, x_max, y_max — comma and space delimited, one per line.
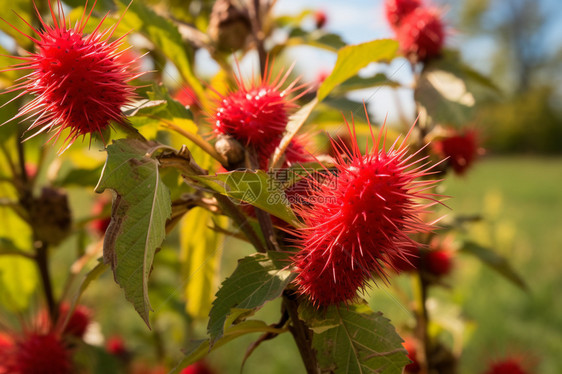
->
438, 157, 562, 374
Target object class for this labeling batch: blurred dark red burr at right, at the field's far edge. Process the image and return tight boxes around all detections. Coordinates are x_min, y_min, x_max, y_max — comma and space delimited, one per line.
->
433, 130, 478, 175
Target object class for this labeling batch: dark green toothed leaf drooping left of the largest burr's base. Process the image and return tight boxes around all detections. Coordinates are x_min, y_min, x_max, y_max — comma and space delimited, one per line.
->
207, 253, 295, 345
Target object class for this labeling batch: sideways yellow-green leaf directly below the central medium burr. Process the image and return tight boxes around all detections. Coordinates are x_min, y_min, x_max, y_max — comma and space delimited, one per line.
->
191, 170, 300, 226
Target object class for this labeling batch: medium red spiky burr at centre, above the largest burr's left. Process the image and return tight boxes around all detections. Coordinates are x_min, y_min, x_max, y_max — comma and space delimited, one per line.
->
213, 61, 305, 167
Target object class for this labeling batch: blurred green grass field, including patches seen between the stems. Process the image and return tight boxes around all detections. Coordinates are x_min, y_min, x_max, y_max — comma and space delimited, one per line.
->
211, 157, 562, 374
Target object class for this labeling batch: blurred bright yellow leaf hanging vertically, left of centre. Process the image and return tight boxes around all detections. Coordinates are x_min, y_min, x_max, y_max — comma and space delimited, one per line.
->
180, 208, 227, 319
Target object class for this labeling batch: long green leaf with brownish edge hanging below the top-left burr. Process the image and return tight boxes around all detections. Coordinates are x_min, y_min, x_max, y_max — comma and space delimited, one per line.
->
96, 139, 172, 326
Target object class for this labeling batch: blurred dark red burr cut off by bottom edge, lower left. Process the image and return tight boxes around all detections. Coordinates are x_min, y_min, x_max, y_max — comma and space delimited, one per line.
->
4, 333, 72, 374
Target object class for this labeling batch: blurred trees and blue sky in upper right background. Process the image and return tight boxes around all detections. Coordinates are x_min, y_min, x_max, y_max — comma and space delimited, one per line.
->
440, 0, 562, 154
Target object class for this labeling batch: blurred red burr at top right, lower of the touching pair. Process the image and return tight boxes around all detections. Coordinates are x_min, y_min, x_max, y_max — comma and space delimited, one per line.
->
396, 8, 445, 61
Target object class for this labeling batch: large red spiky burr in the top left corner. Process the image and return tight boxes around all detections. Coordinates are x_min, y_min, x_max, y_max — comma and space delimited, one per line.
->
1, 0, 140, 149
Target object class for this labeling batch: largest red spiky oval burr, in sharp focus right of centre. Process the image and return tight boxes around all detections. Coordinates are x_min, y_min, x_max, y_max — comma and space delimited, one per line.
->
294, 114, 437, 306
